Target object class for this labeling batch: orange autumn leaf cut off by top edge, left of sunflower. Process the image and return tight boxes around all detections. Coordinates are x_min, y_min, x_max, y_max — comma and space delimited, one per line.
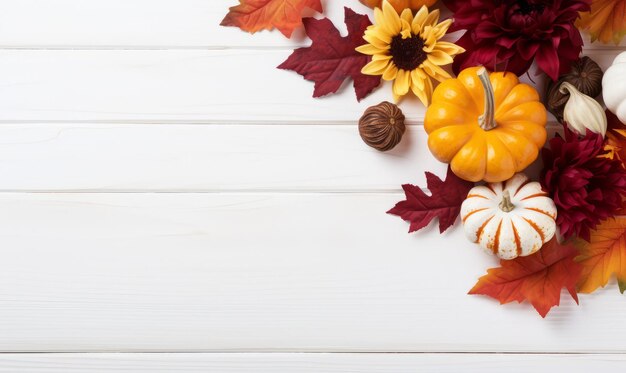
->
220, 0, 323, 38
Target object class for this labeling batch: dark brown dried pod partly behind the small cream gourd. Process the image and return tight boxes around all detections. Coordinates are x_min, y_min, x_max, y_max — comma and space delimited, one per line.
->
546, 56, 604, 121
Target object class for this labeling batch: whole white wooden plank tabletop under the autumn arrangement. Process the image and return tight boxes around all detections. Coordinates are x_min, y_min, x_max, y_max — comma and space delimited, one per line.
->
0, 0, 626, 373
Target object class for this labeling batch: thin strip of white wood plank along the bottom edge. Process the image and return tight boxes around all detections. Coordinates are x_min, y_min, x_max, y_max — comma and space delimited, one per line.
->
0, 353, 626, 373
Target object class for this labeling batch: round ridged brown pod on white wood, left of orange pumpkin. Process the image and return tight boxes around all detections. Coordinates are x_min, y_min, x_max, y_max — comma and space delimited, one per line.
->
359, 101, 406, 152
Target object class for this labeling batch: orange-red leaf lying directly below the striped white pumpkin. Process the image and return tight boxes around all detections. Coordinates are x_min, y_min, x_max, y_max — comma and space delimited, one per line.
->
469, 238, 582, 317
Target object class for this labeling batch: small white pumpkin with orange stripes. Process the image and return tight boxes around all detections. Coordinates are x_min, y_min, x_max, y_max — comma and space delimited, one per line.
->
461, 173, 556, 259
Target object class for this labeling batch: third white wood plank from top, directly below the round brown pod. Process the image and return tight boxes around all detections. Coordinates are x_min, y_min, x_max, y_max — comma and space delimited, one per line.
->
0, 123, 556, 192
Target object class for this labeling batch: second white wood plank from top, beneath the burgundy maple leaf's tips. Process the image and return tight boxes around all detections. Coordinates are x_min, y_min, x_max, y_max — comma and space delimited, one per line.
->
0, 50, 619, 124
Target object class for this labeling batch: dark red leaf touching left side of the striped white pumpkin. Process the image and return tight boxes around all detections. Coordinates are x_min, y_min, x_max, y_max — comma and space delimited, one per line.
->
387, 167, 474, 233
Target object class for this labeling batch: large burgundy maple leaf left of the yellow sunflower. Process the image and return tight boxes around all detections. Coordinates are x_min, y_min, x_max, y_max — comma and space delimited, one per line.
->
278, 8, 380, 101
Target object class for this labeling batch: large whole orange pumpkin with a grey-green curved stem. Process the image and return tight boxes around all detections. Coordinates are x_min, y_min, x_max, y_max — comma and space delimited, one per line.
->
424, 67, 547, 182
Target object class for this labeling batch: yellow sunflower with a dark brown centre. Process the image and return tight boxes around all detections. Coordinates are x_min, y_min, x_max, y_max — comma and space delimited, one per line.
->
356, 0, 465, 106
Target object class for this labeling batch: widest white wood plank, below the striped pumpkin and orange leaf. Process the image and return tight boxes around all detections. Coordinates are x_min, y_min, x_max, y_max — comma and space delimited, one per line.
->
0, 193, 626, 353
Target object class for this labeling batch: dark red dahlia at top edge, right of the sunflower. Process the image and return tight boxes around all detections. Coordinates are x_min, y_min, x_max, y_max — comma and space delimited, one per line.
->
443, 0, 590, 80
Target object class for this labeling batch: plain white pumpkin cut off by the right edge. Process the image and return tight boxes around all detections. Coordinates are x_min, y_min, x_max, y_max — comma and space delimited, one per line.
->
602, 52, 626, 123
